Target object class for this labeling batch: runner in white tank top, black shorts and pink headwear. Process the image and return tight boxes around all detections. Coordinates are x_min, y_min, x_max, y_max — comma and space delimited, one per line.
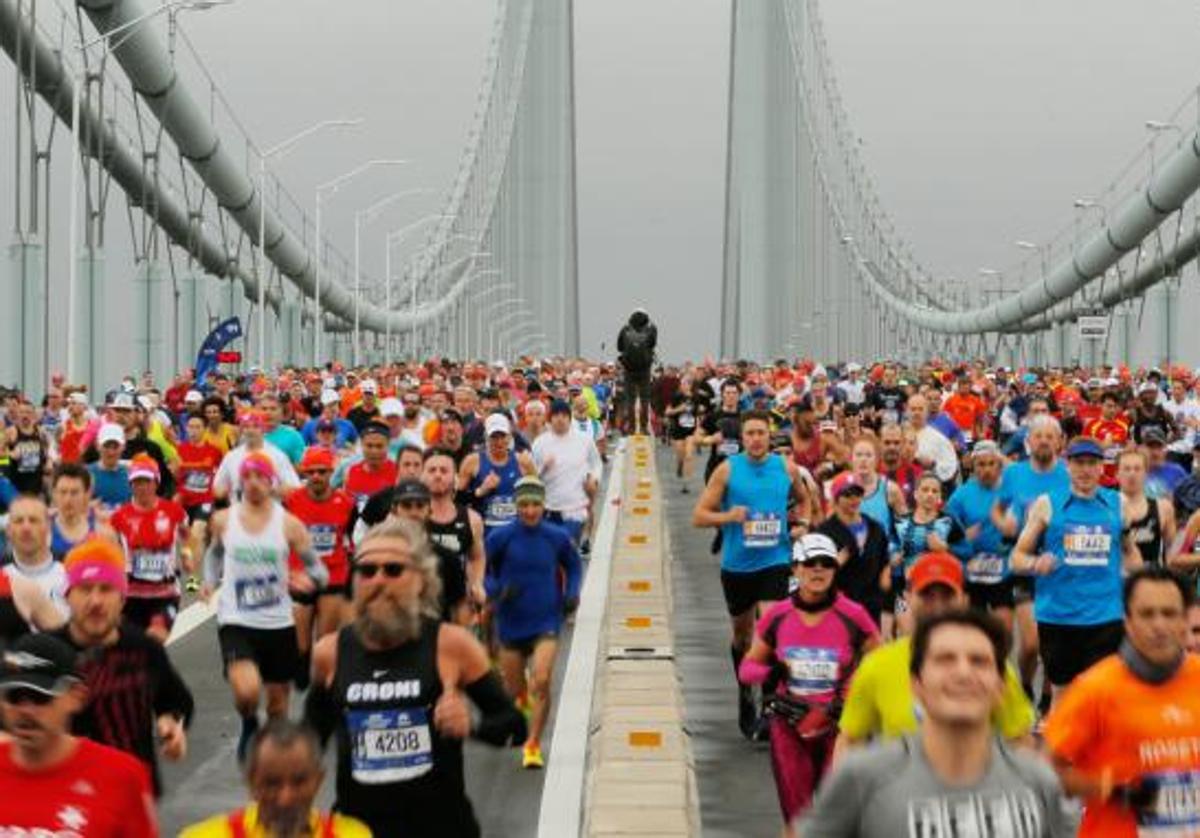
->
200, 451, 329, 762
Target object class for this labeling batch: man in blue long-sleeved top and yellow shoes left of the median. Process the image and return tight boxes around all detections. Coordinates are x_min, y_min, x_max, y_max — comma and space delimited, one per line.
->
484, 477, 583, 768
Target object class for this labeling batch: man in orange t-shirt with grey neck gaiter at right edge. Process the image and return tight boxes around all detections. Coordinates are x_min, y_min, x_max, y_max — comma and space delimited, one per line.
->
1045, 565, 1200, 838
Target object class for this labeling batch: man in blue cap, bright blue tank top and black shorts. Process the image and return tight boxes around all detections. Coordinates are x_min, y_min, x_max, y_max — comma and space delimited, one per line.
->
1012, 438, 1141, 699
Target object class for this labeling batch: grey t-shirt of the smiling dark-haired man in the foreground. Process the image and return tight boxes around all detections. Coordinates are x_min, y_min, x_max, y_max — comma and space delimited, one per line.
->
800, 737, 1075, 838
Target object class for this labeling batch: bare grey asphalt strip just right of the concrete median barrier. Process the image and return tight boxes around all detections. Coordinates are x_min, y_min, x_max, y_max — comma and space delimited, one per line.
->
656, 445, 782, 838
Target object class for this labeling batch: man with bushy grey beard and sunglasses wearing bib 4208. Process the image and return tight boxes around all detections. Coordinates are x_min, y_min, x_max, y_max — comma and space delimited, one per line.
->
305, 519, 526, 838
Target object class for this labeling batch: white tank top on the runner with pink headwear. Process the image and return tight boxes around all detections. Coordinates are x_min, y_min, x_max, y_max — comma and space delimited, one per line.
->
217, 501, 293, 629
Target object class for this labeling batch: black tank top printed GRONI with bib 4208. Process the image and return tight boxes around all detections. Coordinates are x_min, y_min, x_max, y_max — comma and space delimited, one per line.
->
334, 617, 479, 838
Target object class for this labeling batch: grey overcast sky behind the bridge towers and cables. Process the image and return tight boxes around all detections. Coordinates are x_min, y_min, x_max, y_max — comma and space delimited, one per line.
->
7, 0, 1200, 369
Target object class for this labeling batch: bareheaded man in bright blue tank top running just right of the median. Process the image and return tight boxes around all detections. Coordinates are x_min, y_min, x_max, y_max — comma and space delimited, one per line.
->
691, 411, 818, 737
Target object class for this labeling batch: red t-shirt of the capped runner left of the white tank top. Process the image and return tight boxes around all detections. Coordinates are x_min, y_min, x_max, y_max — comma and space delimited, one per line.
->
109, 497, 187, 599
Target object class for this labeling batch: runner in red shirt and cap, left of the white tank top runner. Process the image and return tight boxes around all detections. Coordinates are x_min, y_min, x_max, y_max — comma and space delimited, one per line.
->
109, 454, 194, 644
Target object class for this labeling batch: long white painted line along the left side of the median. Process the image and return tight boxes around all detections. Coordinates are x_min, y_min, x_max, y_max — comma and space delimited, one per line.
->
538, 439, 625, 838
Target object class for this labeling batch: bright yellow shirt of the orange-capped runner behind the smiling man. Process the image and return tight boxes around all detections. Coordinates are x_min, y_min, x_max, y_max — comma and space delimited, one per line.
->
839, 638, 1033, 740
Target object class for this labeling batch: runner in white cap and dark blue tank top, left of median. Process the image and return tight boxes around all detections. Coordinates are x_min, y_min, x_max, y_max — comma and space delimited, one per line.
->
458, 413, 538, 534
